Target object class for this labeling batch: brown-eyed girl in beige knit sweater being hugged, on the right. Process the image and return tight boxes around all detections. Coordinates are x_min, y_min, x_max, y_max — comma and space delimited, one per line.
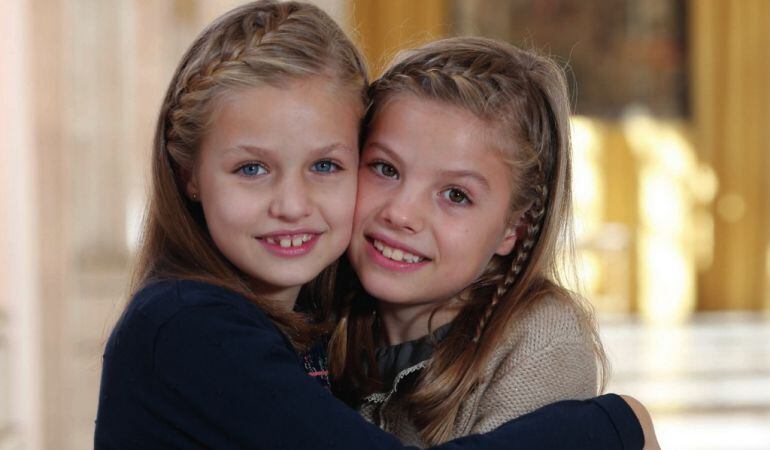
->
330, 38, 605, 446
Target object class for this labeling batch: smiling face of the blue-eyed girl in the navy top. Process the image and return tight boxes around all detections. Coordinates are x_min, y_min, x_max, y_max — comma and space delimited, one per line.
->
186, 78, 360, 308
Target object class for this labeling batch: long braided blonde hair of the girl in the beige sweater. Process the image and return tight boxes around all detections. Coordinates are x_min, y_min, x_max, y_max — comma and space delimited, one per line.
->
330, 37, 606, 445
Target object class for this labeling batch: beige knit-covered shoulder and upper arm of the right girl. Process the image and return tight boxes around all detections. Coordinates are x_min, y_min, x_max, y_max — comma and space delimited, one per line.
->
467, 296, 598, 433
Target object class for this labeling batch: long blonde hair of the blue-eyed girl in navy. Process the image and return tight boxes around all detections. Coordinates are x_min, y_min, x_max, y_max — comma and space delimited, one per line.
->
131, 1, 368, 349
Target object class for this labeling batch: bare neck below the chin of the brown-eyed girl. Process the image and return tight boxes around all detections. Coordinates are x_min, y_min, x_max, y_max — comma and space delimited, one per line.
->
377, 301, 460, 345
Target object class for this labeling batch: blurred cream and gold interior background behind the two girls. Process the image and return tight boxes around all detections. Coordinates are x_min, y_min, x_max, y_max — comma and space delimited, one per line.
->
0, 0, 770, 450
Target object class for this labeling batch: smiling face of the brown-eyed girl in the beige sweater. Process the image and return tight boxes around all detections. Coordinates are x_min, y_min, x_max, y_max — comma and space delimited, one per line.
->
349, 95, 516, 306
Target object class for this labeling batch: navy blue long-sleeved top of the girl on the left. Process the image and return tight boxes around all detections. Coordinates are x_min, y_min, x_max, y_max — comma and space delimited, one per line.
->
94, 280, 643, 450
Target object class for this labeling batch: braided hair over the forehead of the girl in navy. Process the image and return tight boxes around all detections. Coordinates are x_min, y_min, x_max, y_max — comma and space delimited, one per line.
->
163, 1, 368, 174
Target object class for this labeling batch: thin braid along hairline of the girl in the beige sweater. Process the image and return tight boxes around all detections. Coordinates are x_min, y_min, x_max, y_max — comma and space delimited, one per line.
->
374, 38, 552, 343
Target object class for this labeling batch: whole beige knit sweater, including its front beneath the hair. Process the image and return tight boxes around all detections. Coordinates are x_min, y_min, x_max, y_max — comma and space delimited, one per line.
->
360, 298, 598, 447
